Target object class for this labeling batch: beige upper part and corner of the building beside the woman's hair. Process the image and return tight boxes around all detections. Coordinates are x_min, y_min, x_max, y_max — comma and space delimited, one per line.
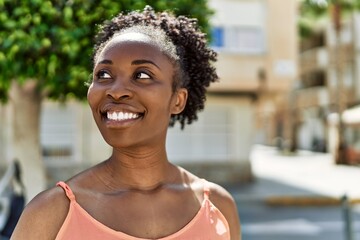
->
210, 0, 298, 148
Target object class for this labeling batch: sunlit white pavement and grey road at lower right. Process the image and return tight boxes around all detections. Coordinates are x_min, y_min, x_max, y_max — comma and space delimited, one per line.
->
227, 145, 360, 240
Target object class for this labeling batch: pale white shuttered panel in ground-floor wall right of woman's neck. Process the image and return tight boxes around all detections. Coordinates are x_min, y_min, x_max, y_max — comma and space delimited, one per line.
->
167, 105, 236, 162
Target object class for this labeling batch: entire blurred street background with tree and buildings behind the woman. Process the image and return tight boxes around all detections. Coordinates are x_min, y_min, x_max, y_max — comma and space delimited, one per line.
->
0, 0, 360, 240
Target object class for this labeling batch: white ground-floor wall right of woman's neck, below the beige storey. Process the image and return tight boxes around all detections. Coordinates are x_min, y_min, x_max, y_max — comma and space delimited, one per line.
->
167, 97, 254, 163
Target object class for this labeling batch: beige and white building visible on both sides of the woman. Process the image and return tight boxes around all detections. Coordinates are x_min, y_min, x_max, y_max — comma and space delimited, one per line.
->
0, 0, 297, 185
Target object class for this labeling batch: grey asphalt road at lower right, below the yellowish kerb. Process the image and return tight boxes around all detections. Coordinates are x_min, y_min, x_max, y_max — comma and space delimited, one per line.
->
237, 179, 360, 240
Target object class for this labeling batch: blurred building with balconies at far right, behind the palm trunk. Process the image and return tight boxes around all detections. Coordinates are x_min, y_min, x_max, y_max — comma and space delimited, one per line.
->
294, 13, 360, 163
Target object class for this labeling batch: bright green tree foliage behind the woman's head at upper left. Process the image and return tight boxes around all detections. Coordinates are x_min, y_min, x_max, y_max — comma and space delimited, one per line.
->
0, 0, 212, 100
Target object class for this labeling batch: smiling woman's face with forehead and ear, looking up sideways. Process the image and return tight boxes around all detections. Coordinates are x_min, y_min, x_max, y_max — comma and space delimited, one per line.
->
88, 33, 187, 148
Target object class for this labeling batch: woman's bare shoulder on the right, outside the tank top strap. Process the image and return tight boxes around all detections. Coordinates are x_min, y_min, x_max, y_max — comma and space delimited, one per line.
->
209, 183, 241, 240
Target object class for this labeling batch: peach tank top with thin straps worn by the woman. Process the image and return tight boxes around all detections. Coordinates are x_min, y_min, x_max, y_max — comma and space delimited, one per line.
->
55, 182, 230, 240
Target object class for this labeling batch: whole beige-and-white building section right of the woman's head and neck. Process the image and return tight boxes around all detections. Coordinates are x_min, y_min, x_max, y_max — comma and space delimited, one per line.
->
169, 0, 298, 182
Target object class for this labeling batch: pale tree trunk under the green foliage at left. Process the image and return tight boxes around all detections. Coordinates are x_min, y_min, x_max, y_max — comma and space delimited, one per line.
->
10, 80, 46, 201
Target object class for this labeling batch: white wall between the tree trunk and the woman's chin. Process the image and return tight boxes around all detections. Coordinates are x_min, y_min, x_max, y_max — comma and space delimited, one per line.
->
40, 101, 111, 166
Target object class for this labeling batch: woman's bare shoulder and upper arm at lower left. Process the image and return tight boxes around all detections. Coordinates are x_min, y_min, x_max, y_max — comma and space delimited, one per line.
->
11, 187, 70, 240
